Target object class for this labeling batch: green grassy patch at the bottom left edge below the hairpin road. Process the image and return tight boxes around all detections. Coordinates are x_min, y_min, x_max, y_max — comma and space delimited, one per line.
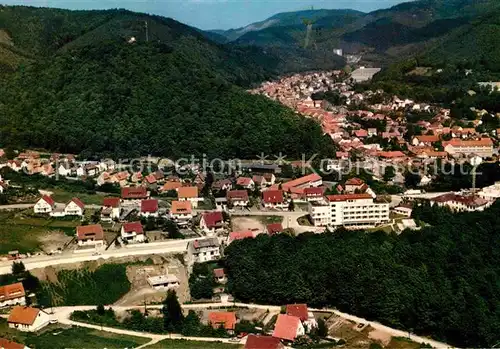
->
24, 327, 149, 349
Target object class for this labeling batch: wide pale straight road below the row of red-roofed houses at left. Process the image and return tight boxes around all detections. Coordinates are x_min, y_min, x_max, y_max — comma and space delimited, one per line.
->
0, 238, 197, 275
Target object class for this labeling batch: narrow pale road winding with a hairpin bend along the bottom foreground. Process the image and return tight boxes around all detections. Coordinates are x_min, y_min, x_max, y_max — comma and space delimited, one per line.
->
51, 302, 453, 349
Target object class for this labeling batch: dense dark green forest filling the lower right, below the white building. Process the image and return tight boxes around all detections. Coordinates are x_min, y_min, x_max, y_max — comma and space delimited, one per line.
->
225, 204, 500, 347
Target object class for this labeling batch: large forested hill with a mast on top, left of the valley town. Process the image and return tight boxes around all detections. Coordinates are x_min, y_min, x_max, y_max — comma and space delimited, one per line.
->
0, 7, 331, 158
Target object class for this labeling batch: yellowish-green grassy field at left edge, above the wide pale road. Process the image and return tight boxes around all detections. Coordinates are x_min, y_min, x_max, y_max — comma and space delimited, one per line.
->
0, 210, 80, 254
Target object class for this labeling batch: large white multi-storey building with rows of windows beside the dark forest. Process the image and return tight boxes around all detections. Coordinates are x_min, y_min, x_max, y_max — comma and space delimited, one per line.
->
309, 193, 389, 228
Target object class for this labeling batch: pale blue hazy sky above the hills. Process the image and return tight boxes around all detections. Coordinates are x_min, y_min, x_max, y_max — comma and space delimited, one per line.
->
0, 0, 409, 29
